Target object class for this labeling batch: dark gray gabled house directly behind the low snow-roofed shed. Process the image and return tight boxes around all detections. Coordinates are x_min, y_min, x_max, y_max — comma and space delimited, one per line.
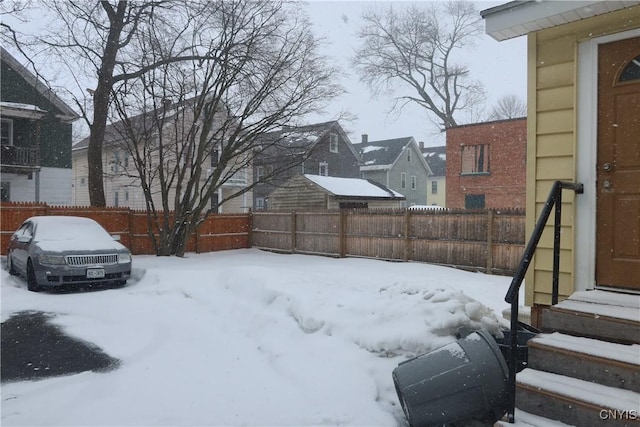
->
253, 121, 361, 210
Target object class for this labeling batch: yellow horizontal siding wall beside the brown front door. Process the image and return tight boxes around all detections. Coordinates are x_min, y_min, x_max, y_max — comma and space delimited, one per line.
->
525, 6, 640, 305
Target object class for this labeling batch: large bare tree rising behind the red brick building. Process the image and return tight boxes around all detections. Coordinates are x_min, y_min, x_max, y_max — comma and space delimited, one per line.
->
352, 0, 484, 130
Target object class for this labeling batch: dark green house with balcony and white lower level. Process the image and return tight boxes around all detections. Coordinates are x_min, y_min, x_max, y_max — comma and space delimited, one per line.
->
0, 47, 79, 205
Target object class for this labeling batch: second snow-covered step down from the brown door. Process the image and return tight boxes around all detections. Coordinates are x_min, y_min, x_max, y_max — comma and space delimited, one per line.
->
528, 332, 640, 393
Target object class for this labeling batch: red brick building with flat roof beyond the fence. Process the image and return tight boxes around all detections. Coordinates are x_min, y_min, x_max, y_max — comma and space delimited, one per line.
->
446, 118, 527, 209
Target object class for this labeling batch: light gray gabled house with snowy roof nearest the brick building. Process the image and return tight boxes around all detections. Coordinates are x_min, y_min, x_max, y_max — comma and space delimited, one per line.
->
356, 135, 431, 207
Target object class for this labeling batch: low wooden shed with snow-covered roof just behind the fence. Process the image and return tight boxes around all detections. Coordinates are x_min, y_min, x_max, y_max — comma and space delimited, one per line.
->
269, 174, 404, 210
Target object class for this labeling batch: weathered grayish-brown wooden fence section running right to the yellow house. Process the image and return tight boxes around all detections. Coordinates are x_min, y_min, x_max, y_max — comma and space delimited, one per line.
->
251, 209, 525, 275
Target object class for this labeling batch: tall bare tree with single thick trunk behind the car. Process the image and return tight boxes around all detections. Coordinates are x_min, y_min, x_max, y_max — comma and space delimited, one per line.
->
34, 0, 230, 206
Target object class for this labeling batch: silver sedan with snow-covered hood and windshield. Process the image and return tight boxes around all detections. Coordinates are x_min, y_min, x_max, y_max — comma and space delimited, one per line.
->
7, 216, 131, 291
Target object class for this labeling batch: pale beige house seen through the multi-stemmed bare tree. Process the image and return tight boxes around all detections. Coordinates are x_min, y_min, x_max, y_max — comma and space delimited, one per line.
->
73, 101, 252, 213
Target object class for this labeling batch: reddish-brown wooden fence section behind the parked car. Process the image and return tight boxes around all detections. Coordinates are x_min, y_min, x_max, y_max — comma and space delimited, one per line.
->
0, 202, 251, 255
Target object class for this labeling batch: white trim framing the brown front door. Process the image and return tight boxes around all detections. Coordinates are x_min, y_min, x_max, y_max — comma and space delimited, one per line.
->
574, 29, 640, 291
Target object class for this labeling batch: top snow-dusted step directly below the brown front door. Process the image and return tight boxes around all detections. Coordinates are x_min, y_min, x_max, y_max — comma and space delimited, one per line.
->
541, 291, 640, 344
